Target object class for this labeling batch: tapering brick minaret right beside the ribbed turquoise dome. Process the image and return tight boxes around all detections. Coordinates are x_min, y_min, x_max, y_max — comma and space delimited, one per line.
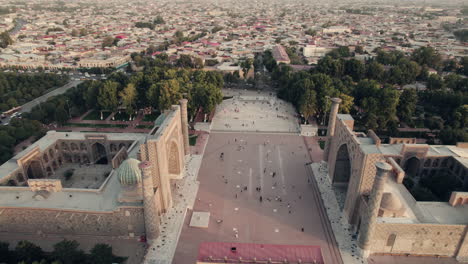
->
139, 161, 159, 240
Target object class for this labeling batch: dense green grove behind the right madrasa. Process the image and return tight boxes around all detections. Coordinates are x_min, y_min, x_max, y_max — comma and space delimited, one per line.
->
266, 47, 468, 144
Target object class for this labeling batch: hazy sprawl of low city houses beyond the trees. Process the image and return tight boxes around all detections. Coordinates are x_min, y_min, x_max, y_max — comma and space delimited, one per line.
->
0, 1, 466, 71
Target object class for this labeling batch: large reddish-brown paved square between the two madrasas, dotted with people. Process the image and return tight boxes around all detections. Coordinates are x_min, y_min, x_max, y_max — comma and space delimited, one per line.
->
172, 133, 342, 264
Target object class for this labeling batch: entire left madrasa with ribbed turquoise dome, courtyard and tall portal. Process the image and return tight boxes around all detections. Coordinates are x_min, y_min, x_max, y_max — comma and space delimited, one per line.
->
0, 99, 189, 240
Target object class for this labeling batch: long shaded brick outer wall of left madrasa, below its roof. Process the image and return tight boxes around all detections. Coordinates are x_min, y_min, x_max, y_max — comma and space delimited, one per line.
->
0, 207, 145, 237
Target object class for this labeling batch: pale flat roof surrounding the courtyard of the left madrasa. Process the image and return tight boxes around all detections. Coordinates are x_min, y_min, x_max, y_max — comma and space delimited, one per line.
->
0, 131, 146, 212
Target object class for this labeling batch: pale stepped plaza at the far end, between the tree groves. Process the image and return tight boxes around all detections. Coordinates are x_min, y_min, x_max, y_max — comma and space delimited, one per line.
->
211, 90, 300, 133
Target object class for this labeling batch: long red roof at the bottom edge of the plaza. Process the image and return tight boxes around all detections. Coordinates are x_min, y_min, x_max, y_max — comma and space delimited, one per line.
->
198, 242, 324, 264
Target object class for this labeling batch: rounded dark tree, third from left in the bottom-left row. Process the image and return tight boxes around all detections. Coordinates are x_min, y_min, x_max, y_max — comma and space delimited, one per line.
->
52, 240, 86, 264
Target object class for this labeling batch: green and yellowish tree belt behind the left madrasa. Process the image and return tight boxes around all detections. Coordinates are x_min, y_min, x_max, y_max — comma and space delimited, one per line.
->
25, 55, 224, 124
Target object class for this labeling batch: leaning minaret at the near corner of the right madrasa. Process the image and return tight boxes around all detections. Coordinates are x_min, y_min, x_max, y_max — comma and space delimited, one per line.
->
358, 162, 392, 255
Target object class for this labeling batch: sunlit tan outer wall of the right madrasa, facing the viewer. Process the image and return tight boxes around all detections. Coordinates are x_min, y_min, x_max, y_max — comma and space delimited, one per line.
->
371, 223, 466, 257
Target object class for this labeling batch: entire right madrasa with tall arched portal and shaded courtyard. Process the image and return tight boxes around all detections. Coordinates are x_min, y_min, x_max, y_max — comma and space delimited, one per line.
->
324, 98, 468, 261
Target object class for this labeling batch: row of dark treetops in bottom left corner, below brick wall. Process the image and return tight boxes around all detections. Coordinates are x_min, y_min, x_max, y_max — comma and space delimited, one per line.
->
0, 240, 127, 264
